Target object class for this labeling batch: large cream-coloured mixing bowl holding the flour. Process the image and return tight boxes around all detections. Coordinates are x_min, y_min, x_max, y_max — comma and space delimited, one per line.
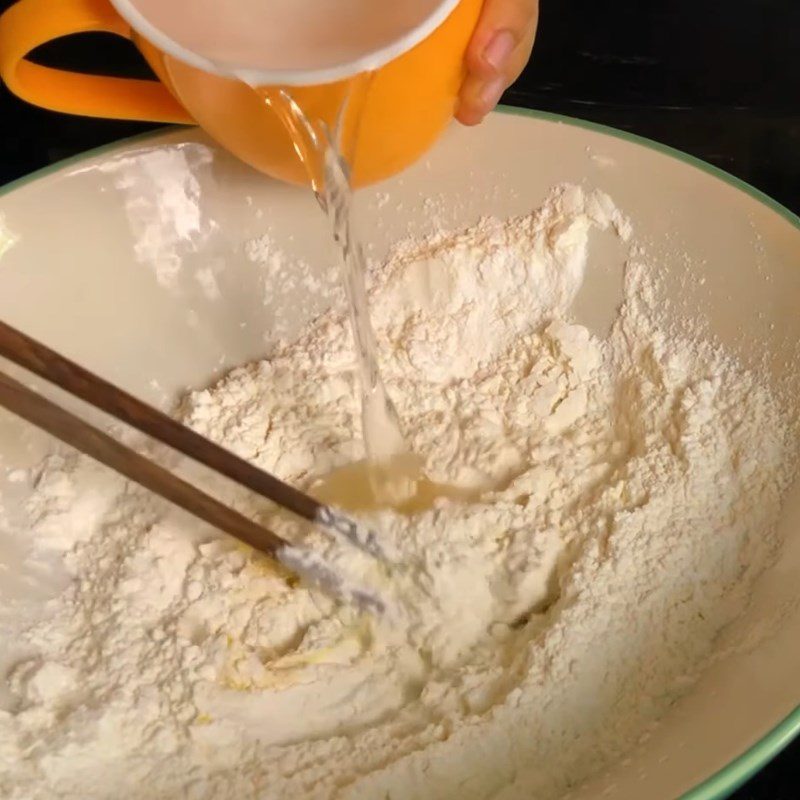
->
0, 108, 800, 800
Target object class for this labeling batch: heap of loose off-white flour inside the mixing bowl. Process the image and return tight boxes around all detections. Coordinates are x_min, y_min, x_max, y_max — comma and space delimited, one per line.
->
0, 187, 792, 800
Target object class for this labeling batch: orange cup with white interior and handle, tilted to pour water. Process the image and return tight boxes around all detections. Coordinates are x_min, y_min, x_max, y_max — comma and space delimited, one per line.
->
0, 0, 482, 185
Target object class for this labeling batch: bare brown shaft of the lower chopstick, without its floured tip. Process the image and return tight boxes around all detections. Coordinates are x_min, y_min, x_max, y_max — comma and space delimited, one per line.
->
0, 372, 288, 557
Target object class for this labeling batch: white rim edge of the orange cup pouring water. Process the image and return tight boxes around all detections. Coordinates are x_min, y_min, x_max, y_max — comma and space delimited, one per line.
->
110, 0, 460, 86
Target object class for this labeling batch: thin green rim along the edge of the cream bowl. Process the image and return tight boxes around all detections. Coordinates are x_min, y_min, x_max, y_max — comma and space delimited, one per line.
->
0, 106, 800, 800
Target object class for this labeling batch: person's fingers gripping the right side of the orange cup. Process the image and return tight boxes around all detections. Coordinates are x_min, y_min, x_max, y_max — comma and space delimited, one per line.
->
456, 0, 539, 125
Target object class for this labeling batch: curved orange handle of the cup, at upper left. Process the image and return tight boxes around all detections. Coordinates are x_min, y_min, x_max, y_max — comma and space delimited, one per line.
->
0, 0, 194, 124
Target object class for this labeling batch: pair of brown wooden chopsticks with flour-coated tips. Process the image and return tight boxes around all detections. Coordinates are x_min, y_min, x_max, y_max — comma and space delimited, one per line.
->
0, 322, 389, 613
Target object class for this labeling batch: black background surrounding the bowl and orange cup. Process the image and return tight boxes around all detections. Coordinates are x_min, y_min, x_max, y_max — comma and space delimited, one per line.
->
0, 0, 800, 800
